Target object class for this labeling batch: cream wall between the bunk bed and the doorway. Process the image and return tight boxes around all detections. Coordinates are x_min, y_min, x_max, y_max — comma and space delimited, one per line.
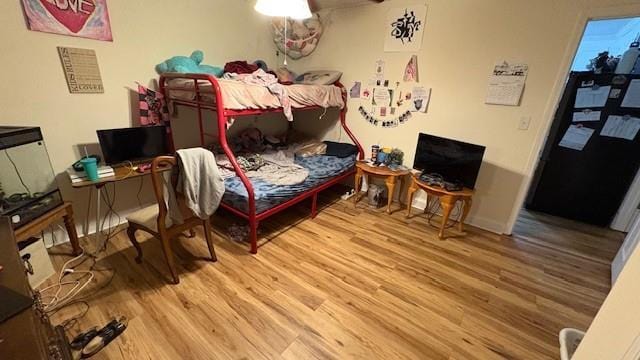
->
282, 0, 634, 232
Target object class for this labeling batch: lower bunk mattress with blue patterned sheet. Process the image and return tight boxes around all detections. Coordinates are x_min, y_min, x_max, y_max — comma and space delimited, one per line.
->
222, 155, 356, 214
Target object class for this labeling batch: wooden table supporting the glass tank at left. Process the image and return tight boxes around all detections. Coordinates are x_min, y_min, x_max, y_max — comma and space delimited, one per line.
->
15, 202, 82, 255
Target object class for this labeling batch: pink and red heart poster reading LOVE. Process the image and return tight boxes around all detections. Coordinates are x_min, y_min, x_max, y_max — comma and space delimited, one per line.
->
22, 0, 113, 41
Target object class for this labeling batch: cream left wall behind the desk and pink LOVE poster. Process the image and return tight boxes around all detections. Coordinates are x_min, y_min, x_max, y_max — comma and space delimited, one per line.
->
0, 0, 275, 243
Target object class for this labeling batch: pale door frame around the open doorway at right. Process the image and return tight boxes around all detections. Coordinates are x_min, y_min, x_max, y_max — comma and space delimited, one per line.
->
505, 5, 640, 235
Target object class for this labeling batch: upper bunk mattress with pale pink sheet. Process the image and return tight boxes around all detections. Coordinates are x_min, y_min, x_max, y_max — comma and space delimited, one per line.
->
167, 79, 344, 110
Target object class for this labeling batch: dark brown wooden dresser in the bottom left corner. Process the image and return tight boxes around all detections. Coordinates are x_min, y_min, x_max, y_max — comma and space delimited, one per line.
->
0, 217, 72, 360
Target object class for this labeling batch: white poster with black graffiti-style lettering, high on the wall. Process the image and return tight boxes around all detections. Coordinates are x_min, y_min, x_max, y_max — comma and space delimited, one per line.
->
384, 5, 427, 52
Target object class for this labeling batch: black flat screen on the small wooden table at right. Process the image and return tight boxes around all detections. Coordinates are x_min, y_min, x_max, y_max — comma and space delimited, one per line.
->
413, 133, 485, 189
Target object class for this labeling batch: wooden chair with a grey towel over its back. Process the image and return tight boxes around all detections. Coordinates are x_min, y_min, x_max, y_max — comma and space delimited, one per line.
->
127, 156, 217, 284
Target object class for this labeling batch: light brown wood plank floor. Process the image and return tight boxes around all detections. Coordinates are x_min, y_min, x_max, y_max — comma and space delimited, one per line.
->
48, 197, 621, 360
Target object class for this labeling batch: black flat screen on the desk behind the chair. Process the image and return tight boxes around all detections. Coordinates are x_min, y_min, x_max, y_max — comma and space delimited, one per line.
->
97, 126, 169, 165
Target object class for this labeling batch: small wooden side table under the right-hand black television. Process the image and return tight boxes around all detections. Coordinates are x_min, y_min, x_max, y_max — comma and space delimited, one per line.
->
407, 174, 474, 239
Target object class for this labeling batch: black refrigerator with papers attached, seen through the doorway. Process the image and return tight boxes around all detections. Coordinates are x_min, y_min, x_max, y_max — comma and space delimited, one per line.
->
525, 72, 640, 227
